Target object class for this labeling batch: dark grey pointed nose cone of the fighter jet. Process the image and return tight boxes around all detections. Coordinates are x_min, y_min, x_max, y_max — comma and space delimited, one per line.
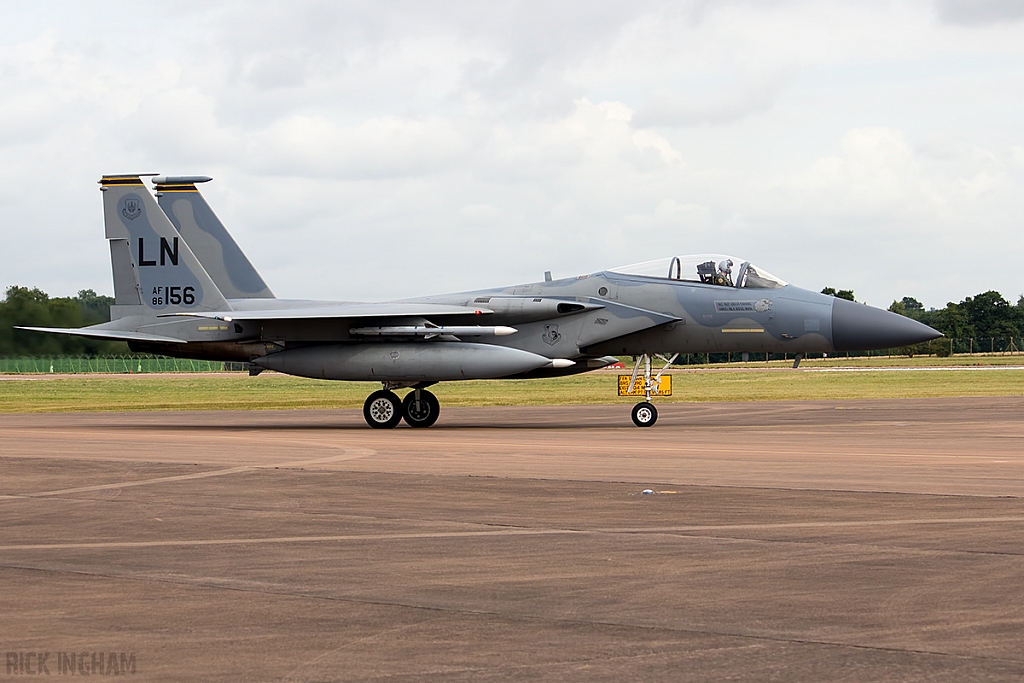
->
833, 299, 942, 351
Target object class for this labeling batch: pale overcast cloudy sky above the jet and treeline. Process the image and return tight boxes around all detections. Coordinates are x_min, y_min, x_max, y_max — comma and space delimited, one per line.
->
0, 0, 1024, 306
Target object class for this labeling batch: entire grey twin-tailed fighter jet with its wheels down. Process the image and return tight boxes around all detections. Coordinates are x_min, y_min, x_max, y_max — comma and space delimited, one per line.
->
20, 174, 941, 429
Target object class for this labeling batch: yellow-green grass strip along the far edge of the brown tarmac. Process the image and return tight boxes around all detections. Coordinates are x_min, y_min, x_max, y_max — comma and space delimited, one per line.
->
0, 356, 1024, 413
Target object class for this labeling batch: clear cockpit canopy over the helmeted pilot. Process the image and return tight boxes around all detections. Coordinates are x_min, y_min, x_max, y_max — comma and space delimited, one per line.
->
610, 254, 786, 290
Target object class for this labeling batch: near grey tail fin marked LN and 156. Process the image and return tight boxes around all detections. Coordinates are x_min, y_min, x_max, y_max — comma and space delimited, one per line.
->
99, 175, 230, 313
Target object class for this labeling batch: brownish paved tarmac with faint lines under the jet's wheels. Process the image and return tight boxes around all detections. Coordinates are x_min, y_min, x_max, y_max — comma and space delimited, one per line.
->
0, 397, 1024, 681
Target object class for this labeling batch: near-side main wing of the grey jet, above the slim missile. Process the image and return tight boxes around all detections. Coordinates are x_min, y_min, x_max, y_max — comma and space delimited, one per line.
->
158, 302, 495, 323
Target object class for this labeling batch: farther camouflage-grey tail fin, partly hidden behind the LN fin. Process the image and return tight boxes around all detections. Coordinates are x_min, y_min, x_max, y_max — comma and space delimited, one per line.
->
153, 175, 273, 299
